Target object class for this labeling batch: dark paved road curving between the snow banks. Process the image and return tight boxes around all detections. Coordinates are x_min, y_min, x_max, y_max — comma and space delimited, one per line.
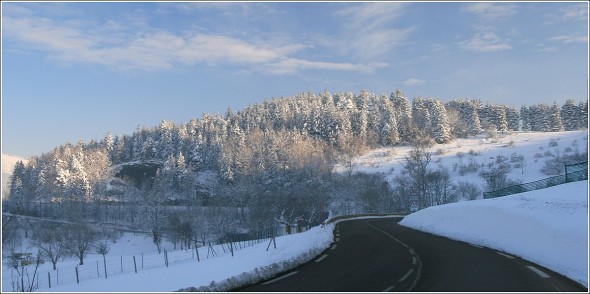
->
238, 218, 588, 292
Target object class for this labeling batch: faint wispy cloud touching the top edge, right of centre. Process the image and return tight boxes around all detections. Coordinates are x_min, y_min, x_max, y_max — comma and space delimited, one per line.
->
335, 2, 413, 60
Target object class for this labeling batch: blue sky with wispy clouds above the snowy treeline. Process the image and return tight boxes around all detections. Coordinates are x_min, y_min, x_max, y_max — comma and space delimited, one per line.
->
2, 2, 588, 157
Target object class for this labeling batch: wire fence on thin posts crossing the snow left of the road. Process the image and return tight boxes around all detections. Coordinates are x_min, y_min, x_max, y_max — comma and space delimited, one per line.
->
4, 227, 286, 291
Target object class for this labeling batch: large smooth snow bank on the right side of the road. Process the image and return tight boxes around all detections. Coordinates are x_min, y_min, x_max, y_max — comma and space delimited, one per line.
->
399, 181, 588, 287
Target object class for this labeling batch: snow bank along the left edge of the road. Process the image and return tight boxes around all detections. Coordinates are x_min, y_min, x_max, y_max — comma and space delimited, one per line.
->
31, 224, 334, 292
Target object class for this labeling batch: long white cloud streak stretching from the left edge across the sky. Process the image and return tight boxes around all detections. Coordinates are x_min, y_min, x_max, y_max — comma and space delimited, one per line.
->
3, 12, 385, 74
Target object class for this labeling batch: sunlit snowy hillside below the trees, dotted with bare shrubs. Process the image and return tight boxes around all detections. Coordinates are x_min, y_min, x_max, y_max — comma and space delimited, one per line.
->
335, 130, 588, 197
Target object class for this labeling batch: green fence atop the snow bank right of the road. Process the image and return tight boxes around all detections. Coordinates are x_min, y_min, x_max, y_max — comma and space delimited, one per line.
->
483, 161, 588, 199
